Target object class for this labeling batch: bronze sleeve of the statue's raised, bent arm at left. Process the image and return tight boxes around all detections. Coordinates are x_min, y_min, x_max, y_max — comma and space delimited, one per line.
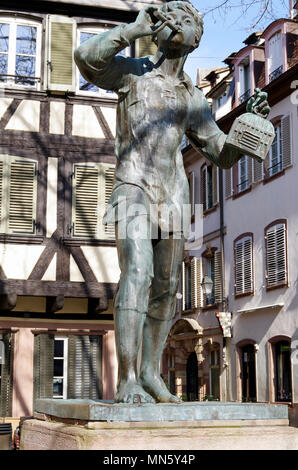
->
74, 25, 133, 92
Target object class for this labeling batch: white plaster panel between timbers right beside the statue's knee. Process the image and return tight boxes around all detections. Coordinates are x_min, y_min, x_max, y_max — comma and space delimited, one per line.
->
82, 246, 120, 283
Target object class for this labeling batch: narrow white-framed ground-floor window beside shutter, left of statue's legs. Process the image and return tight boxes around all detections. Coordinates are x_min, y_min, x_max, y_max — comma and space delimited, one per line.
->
53, 336, 68, 399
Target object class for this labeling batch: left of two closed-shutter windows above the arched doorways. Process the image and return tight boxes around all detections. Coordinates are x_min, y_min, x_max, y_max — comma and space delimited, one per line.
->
234, 235, 253, 295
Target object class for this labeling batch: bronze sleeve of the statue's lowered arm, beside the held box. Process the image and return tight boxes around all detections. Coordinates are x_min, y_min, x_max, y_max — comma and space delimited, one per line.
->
186, 89, 242, 168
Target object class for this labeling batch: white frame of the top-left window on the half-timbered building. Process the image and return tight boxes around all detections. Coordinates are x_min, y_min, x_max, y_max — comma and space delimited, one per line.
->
0, 15, 42, 91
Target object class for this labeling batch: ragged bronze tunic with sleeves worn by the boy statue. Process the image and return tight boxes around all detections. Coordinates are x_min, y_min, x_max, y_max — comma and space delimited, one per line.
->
75, 25, 226, 231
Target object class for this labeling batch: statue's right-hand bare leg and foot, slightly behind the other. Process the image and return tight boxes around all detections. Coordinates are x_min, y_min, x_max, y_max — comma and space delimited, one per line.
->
140, 236, 185, 403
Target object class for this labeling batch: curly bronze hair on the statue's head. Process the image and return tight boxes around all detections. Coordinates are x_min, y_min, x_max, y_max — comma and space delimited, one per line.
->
155, 0, 204, 49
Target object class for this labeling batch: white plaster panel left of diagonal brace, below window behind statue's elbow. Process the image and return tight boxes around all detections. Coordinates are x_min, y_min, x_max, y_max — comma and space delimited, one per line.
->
72, 104, 104, 139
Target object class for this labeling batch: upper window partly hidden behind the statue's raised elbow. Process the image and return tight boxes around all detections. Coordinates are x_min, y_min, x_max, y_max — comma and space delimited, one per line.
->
77, 28, 130, 98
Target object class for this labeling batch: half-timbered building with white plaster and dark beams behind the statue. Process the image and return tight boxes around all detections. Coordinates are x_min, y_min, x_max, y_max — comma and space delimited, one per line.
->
0, 0, 162, 417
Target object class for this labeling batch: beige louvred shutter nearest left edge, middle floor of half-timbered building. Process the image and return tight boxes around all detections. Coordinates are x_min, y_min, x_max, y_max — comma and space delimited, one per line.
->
8, 159, 37, 233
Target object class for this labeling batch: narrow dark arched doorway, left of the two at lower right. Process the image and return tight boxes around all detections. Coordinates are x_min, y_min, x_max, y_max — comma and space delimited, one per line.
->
241, 344, 257, 402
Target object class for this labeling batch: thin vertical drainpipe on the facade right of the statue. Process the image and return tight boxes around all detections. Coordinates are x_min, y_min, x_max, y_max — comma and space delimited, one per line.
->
218, 168, 231, 401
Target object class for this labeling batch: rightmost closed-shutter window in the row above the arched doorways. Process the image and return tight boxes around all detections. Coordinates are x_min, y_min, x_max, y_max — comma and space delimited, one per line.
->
265, 222, 288, 288
